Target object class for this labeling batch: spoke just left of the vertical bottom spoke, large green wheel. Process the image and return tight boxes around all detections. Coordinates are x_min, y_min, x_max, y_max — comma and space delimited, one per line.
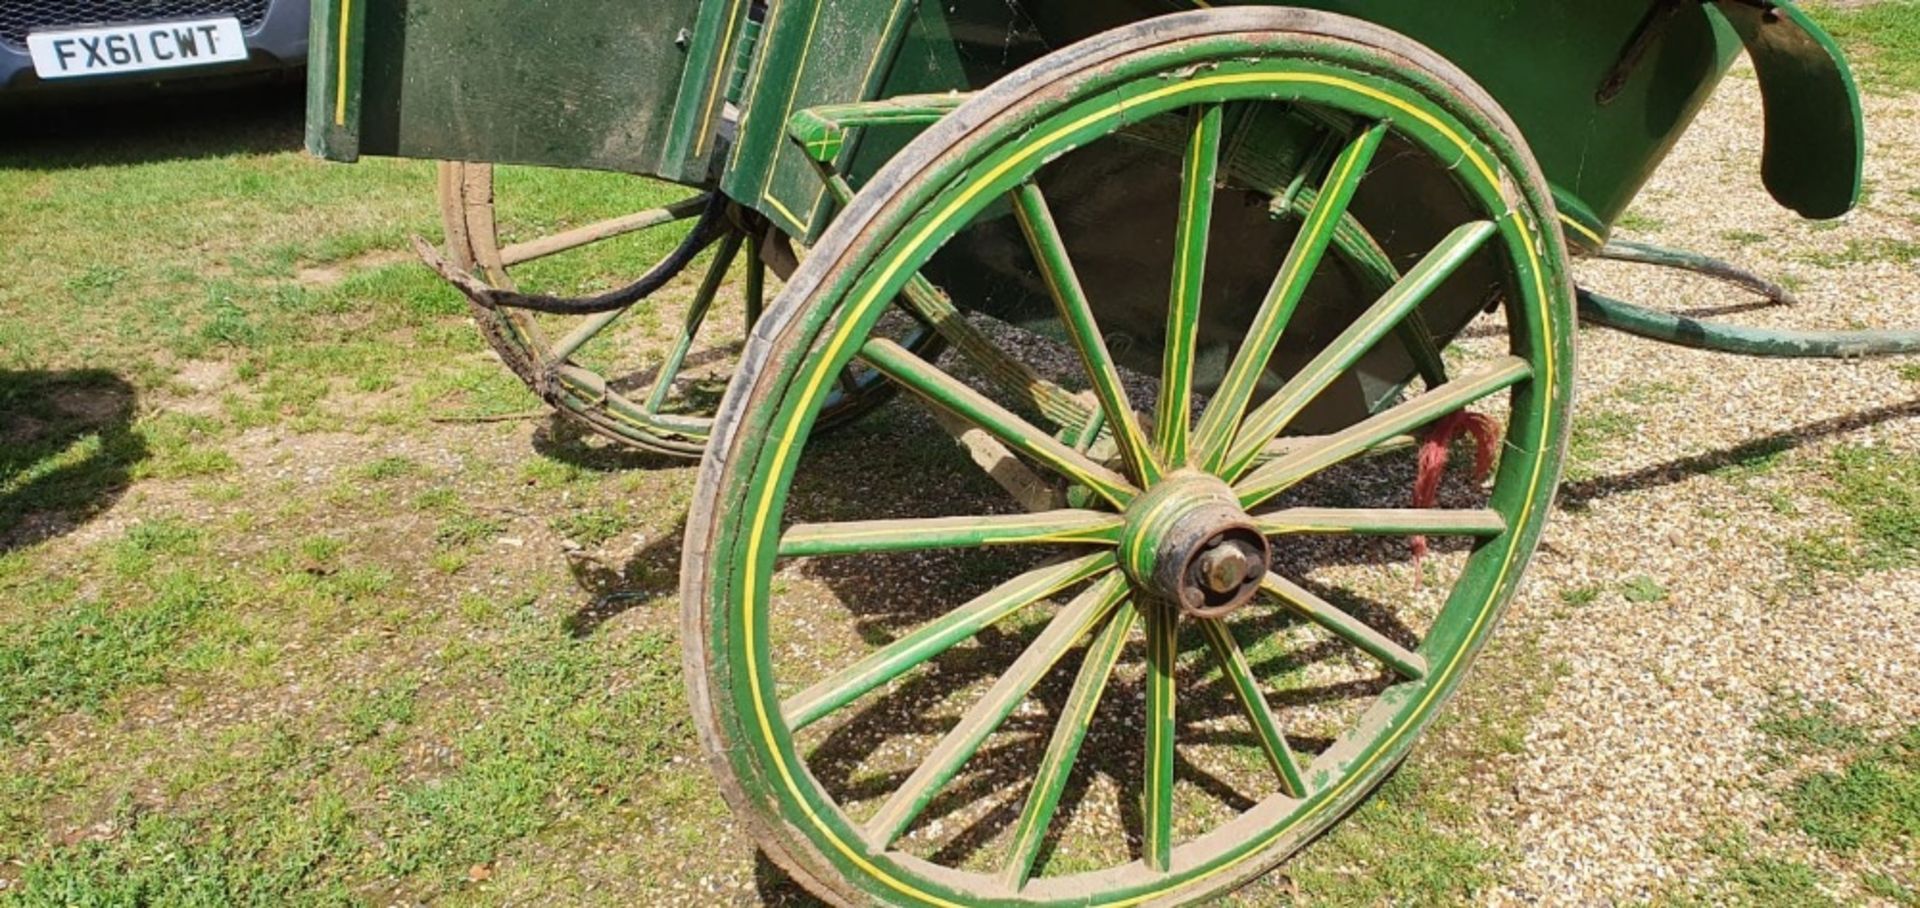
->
1000, 605, 1139, 889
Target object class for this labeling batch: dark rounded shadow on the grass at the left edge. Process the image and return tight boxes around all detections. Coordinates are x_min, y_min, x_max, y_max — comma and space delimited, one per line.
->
0, 369, 148, 555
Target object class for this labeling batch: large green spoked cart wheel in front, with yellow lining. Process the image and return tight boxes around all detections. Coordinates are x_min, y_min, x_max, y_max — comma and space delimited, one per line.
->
684, 8, 1572, 904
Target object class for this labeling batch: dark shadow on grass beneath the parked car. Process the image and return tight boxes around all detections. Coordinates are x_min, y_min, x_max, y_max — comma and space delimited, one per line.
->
0, 79, 305, 171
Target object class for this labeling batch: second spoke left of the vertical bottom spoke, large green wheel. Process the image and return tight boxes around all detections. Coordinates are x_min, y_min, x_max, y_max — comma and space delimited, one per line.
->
864, 572, 1127, 848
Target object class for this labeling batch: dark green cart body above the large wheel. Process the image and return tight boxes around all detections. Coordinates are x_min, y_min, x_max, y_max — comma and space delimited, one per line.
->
309, 0, 1862, 248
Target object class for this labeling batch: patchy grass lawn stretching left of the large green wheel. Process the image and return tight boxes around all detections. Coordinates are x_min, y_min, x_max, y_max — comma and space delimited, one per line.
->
0, 81, 1538, 904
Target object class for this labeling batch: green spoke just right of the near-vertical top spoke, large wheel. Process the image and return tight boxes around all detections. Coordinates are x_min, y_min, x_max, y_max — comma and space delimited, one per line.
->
1194, 123, 1386, 470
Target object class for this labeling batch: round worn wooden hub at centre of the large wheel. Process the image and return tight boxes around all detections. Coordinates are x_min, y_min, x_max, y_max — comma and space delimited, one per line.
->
1119, 474, 1273, 618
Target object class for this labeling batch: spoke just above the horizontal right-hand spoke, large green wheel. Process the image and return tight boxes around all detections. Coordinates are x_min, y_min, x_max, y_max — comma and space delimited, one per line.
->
1235, 357, 1532, 509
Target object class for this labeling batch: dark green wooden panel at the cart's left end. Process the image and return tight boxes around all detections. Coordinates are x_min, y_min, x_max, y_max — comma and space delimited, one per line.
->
309, 0, 721, 180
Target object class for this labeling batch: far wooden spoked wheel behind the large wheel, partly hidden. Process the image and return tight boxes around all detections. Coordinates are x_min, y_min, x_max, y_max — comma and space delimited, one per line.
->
440, 161, 937, 457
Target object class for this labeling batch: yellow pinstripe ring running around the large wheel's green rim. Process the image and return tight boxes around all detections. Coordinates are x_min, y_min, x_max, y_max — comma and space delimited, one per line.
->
739, 73, 1555, 908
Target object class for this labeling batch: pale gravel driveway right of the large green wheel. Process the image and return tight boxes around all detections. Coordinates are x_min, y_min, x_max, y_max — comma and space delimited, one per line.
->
1484, 61, 1920, 904
